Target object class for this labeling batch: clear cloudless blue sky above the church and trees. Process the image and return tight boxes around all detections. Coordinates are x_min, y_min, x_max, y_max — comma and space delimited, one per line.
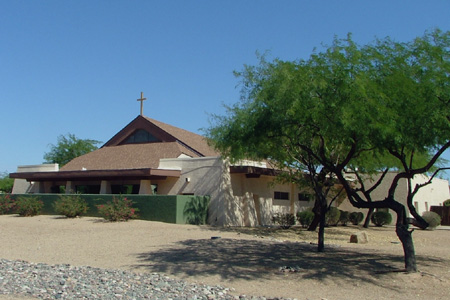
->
0, 0, 450, 179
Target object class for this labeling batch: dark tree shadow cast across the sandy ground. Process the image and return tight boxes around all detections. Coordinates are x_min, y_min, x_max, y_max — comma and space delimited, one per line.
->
131, 239, 448, 286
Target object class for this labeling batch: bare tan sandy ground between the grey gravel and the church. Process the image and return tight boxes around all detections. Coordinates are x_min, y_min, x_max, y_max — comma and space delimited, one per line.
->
0, 215, 450, 300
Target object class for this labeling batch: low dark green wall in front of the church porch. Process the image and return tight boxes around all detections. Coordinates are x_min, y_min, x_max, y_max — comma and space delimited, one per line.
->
7, 194, 209, 225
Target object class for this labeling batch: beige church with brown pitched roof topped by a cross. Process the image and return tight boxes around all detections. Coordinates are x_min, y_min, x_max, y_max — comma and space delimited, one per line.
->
10, 94, 312, 226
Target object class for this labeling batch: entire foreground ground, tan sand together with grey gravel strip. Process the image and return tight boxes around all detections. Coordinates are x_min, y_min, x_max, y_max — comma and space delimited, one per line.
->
0, 215, 450, 300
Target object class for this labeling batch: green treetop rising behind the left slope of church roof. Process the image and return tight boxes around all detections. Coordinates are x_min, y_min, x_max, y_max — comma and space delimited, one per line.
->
44, 133, 101, 166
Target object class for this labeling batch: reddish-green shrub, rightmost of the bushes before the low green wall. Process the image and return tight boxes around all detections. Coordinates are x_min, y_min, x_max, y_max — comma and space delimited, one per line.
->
97, 196, 139, 222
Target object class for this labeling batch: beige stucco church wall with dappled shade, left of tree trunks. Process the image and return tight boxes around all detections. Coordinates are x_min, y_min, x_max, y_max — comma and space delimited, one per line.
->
158, 157, 313, 226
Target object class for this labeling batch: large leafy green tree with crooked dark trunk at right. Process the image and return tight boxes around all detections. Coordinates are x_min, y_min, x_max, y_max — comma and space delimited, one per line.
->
207, 30, 450, 271
